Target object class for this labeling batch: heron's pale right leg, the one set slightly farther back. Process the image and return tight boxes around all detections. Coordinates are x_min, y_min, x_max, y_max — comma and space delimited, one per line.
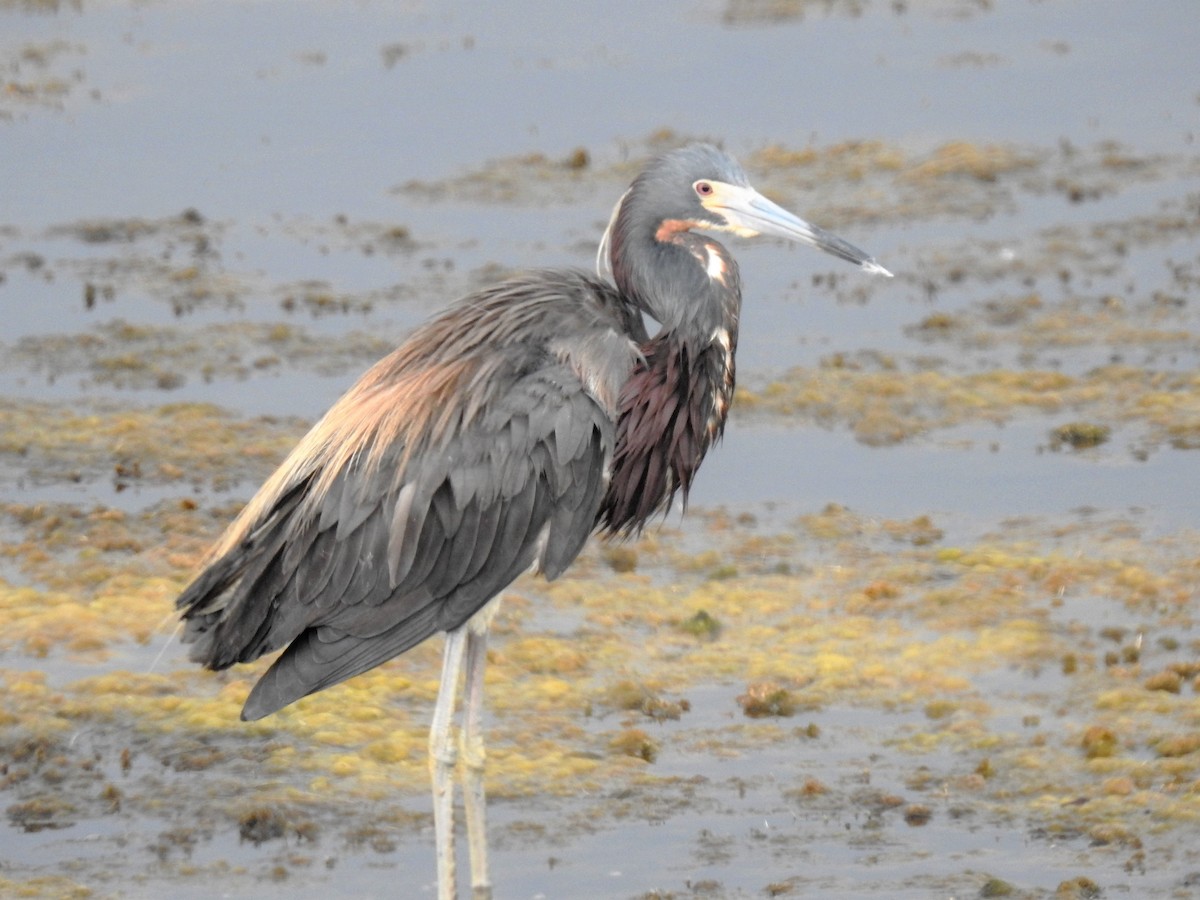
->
461, 626, 492, 900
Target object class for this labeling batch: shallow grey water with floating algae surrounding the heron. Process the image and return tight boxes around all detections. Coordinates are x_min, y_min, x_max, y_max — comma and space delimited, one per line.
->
0, 0, 1200, 898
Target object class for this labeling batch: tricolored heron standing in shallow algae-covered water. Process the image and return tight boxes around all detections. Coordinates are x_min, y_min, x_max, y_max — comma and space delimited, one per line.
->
178, 144, 890, 900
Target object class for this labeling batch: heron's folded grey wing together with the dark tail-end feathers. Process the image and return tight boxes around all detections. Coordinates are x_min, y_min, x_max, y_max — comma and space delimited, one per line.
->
179, 350, 628, 719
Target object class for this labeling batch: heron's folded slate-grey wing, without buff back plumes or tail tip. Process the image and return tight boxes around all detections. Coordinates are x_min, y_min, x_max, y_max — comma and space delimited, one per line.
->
242, 367, 613, 719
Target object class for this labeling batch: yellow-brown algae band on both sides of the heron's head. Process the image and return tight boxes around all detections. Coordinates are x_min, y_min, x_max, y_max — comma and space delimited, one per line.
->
394, 128, 1198, 240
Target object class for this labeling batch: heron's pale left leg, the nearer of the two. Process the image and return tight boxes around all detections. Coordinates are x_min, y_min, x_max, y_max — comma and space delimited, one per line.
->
430, 628, 468, 900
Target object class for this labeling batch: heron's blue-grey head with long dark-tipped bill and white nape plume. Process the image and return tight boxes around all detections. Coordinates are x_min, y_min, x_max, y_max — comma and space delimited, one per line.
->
598, 144, 892, 277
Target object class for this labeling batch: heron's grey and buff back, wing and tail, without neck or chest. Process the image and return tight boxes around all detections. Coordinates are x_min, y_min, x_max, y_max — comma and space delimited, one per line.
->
179, 271, 641, 719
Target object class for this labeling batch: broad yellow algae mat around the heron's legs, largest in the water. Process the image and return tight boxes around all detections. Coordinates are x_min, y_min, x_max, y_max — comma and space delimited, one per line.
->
4, 489, 1200, 864
